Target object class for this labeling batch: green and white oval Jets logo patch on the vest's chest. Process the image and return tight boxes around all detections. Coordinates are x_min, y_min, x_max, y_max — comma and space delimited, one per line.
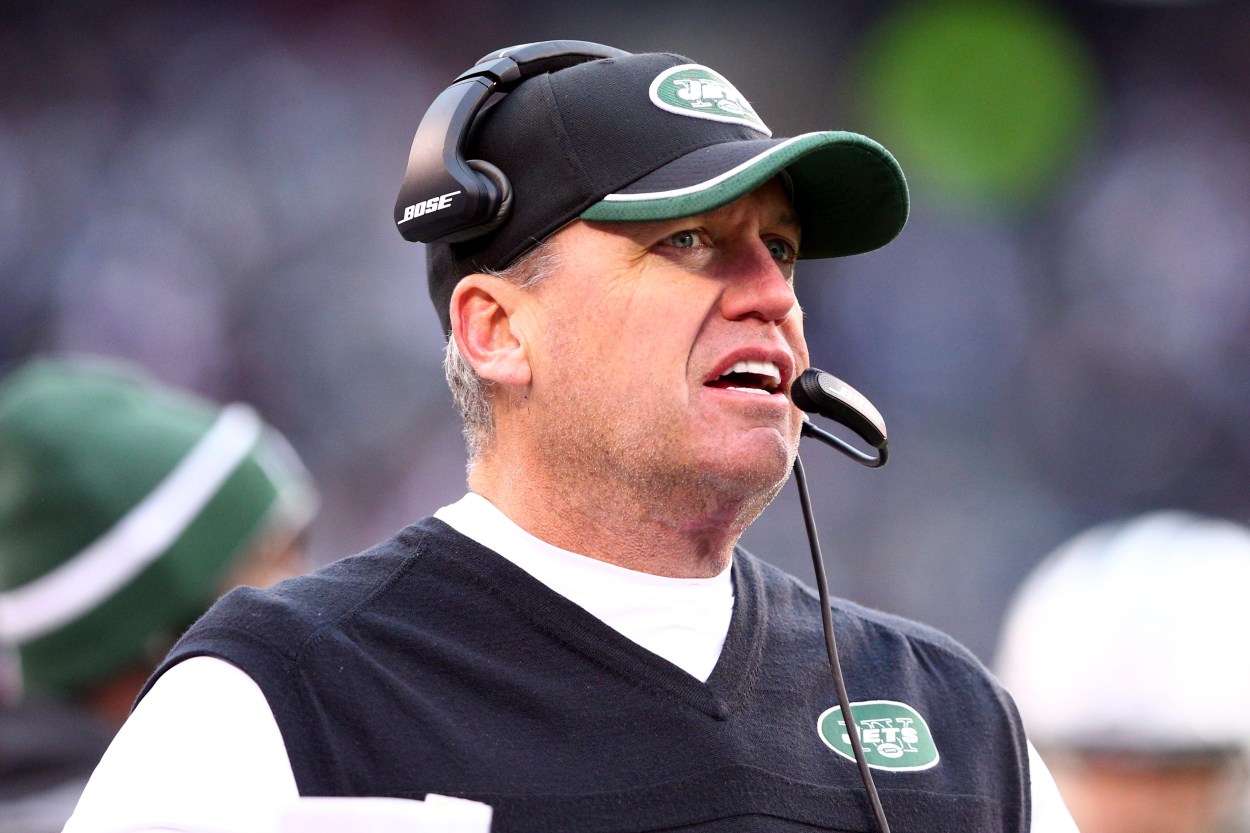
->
816, 700, 939, 772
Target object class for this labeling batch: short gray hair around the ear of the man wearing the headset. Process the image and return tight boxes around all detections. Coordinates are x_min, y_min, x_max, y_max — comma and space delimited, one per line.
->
443, 238, 560, 465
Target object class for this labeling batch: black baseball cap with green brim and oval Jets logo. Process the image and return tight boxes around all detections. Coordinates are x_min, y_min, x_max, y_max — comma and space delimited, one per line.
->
426, 53, 909, 334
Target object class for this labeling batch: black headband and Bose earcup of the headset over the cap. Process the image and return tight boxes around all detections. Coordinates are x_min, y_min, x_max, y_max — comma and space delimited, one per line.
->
395, 40, 630, 243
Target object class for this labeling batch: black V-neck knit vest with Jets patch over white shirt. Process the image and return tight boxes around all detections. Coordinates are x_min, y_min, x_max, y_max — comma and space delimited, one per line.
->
149, 519, 1029, 833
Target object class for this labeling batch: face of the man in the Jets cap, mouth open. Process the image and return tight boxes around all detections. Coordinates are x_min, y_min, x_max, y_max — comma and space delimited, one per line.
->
521, 181, 808, 523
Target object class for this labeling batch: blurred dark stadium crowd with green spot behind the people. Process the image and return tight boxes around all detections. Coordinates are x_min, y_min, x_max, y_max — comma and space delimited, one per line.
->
0, 0, 1250, 659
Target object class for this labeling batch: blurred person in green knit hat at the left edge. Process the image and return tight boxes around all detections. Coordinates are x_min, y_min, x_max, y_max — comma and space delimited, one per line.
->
0, 356, 315, 833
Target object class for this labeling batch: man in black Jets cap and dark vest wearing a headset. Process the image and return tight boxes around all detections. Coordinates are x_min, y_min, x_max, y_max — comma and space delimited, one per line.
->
66, 45, 1071, 833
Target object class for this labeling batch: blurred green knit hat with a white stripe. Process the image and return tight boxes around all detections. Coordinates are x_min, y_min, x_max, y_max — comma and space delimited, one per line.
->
0, 356, 316, 694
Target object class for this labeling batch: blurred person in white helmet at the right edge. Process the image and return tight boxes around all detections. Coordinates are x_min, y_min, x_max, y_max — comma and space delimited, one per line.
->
996, 512, 1250, 833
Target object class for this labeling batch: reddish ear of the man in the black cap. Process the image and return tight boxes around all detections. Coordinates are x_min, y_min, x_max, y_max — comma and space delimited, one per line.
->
450, 274, 531, 386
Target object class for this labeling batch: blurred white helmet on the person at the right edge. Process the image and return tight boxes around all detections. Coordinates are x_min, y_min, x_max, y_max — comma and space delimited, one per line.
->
995, 512, 1250, 754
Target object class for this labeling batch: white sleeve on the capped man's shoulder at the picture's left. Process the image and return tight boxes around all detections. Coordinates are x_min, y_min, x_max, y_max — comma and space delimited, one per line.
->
64, 657, 299, 833
